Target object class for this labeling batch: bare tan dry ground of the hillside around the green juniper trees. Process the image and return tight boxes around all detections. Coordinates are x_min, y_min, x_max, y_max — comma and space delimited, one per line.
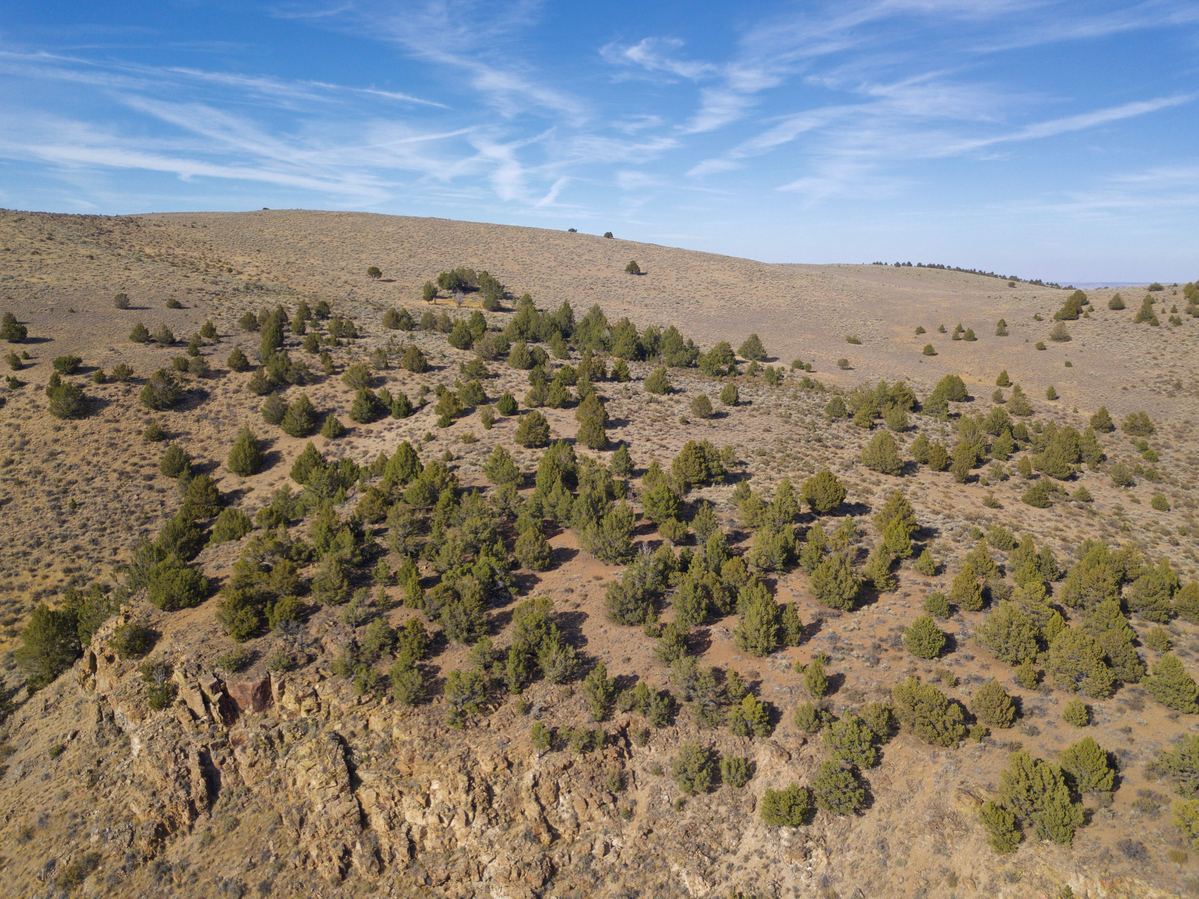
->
0, 211, 1199, 897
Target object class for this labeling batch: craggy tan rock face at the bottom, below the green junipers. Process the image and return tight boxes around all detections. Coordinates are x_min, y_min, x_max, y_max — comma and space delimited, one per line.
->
6, 652, 1167, 899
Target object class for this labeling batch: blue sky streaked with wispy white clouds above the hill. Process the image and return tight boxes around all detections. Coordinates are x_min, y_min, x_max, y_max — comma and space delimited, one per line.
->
0, 0, 1199, 282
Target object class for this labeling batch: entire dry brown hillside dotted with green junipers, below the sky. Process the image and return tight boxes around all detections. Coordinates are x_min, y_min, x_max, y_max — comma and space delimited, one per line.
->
0, 211, 1199, 897
